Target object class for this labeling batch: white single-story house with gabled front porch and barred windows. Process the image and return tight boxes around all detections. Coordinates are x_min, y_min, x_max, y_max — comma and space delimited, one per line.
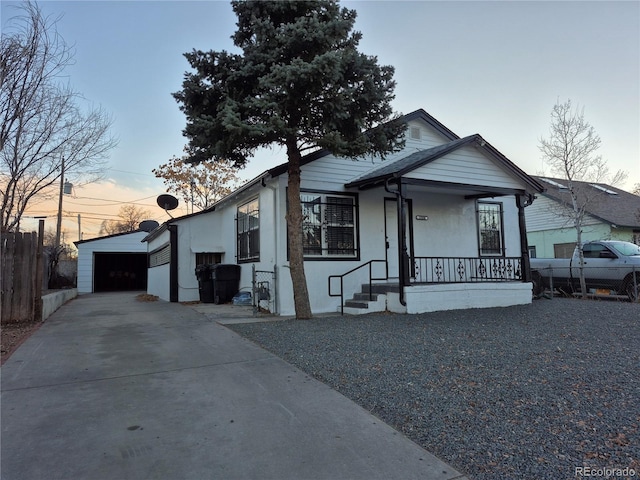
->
145, 110, 543, 315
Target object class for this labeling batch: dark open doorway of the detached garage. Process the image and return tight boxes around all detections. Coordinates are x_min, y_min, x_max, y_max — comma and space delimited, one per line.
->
93, 252, 147, 292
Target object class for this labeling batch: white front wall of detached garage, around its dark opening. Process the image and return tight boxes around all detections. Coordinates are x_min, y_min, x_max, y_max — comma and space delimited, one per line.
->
76, 232, 147, 293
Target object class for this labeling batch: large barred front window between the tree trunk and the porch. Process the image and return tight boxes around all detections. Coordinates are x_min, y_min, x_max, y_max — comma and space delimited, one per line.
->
300, 193, 358, 258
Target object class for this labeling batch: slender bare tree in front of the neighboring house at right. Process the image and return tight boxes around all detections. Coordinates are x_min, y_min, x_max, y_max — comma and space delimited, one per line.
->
539, 100, 627, 298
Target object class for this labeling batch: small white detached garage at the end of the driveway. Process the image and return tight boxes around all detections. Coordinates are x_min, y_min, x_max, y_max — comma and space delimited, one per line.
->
75, 230, 148, 293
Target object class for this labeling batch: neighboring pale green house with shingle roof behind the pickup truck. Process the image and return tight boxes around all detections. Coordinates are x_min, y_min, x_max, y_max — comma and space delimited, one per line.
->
526, 177, 640, 258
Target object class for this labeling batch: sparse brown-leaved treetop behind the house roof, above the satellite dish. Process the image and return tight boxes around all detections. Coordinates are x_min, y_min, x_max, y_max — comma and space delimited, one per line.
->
152, 157, 238, 213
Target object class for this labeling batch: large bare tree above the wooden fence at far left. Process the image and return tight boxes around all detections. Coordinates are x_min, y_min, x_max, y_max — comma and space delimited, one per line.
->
0, 1, 117, 231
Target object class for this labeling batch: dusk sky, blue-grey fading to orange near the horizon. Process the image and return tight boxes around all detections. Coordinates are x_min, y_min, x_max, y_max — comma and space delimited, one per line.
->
1, 0, 640, 240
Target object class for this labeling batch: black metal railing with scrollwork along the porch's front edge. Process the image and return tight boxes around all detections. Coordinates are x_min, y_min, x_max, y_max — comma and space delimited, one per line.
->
412, 257, 522, 283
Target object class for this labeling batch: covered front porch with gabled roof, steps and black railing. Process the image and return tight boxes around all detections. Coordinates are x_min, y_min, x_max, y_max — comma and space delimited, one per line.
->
336, 135, 541, 313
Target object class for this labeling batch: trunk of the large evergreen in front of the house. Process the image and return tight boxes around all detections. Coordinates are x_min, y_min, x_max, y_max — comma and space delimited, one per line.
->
287, 139, 311, 319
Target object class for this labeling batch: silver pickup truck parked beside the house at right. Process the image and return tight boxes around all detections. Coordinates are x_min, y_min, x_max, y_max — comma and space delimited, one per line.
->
531, 240, 640, 302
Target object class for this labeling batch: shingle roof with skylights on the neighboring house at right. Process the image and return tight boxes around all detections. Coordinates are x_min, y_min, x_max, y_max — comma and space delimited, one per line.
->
534, 177, 640, 228
